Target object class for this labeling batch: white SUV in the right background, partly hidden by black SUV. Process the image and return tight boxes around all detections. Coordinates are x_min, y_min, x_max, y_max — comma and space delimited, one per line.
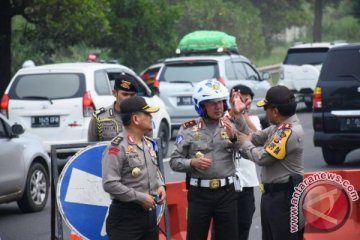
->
278, 42, 346, 109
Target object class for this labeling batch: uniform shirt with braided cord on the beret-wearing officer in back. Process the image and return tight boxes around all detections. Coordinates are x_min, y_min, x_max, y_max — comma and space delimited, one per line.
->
88, 104, 123, 142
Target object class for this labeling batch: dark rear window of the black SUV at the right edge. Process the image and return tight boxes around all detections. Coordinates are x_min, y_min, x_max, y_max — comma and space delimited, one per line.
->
320, 49, 360, 81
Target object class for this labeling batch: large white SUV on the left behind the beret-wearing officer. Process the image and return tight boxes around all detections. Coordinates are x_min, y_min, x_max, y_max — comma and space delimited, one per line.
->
1, 63, 171, 159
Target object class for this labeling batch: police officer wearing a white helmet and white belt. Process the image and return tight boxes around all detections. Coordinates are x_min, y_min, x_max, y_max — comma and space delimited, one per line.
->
170, 79, 238, 240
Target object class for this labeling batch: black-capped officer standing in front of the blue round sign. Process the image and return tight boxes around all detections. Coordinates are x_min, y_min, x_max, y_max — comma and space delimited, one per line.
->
102, 96, 166, 240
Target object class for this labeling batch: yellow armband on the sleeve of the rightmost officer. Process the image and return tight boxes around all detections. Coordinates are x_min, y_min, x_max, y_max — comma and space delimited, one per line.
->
265, 126, 292, 160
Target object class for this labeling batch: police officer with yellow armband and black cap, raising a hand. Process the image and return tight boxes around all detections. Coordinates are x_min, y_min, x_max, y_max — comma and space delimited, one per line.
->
231, 86, 304, 240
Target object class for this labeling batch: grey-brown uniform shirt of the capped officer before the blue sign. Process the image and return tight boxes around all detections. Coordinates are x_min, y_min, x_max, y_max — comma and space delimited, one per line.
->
102, 129, 164, 204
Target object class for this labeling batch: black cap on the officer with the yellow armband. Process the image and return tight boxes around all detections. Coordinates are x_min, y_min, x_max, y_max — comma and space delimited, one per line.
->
256, 85, 295, 107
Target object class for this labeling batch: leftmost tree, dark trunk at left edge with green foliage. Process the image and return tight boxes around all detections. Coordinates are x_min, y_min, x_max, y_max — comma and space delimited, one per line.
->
0, 0, 110, 95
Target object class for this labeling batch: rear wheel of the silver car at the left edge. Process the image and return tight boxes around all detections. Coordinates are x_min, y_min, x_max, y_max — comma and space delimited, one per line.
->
17, 163, 49, 212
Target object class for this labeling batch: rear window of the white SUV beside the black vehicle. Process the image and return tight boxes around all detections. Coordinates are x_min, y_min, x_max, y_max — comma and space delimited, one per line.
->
284, 48, 329, 66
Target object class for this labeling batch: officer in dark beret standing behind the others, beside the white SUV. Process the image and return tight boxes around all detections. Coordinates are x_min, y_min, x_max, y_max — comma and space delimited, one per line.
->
88, 73, 138, 142
